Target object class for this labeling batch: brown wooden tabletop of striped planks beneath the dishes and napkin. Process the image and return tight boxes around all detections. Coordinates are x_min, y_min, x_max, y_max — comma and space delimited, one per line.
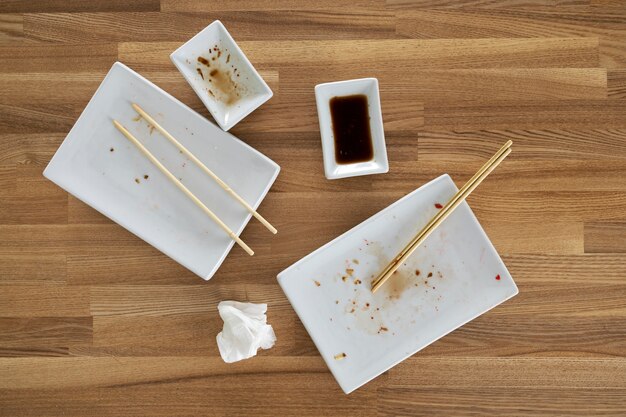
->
0, 0, 626, 417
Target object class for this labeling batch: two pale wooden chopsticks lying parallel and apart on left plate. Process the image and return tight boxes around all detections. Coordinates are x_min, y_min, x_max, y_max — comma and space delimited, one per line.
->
113, 103, 277, 256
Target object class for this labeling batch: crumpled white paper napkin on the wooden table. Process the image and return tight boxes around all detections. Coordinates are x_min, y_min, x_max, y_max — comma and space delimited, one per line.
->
217, 301, 276, 363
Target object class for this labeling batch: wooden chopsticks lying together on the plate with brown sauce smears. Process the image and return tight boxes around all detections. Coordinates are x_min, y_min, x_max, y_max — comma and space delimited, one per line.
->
372, 140, 513, 292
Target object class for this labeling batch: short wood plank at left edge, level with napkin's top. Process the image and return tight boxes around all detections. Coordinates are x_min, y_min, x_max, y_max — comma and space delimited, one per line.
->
0, 285, 90, 317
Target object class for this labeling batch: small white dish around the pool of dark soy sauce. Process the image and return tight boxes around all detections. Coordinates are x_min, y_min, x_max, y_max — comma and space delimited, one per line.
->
315, 78, 389, 180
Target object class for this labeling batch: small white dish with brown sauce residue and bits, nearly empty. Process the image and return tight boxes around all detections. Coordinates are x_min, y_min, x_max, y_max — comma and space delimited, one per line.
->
170, 20, 273, 131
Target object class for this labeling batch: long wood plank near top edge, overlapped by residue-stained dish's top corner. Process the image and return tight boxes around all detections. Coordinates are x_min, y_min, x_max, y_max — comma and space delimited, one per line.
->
24, 10, 396, 43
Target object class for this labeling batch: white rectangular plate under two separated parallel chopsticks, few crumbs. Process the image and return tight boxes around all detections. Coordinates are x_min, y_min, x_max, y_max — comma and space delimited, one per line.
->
44, 62, 280, 280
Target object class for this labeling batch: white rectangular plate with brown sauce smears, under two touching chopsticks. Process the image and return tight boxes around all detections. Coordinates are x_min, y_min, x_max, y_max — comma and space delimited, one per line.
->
278, 175, 518, 393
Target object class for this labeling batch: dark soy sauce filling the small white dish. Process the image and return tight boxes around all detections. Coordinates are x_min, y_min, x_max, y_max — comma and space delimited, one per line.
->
330, 94, 374, 165
